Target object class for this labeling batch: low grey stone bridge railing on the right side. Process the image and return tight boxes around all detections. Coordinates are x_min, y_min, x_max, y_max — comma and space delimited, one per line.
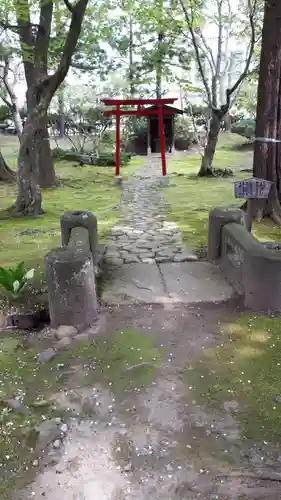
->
208, 208, 281, 312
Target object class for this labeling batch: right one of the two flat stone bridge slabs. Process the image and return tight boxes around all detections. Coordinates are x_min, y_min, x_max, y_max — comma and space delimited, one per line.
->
160, 262, 235, 304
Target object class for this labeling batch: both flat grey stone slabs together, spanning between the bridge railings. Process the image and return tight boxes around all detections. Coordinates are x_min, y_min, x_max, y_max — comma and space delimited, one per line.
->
102, 262, 235, 305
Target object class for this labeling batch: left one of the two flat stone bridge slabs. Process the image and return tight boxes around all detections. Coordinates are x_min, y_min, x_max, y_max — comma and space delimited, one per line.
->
102, 263, 167, 305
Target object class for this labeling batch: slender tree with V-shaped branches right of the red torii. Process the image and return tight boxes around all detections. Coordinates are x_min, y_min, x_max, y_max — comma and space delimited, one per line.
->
179, 0, 257, 176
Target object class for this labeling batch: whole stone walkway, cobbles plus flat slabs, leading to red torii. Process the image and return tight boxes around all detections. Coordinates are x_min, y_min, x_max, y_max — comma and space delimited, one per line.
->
102, 157, 237, 305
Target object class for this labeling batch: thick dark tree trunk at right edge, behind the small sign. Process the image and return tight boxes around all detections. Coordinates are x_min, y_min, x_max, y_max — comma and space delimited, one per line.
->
253, 0, 281, 224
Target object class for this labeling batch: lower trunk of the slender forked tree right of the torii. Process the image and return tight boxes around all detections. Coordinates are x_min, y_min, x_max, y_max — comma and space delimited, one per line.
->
198, 111, 222, 177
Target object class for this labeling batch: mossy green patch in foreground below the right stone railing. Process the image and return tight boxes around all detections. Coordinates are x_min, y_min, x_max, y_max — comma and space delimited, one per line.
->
186, 314, 281, 445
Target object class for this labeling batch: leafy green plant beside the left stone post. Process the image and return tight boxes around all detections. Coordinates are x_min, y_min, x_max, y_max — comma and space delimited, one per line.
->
0, 262, 34, 299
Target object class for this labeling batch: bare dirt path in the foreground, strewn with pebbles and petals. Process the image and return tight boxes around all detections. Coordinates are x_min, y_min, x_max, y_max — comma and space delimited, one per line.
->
12, 302, 281, 500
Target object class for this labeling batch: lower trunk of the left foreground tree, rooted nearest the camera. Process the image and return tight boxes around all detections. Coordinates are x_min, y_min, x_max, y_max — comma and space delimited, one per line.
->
12, 113, 44, 216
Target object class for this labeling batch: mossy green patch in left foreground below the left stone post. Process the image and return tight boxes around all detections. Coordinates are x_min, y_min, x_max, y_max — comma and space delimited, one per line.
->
0, 330, 161, 500
